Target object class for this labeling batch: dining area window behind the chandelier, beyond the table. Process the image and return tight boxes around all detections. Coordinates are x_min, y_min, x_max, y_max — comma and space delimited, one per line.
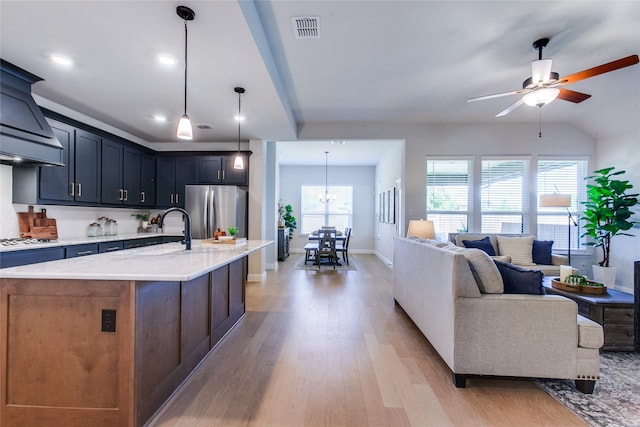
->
300, 185, 353, 234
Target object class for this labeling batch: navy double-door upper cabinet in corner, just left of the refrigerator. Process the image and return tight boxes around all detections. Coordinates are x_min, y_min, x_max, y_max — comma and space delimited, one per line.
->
156, 156, 197, 208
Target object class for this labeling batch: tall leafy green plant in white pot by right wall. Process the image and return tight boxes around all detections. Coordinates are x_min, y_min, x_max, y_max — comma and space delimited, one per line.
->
580, 167, 638, 286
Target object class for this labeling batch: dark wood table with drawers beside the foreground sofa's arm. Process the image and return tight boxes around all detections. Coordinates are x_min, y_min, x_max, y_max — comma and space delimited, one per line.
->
543, 277, 635, 351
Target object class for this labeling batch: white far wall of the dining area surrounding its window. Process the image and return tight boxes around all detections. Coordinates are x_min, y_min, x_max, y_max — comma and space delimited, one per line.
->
279, 166, 375, 253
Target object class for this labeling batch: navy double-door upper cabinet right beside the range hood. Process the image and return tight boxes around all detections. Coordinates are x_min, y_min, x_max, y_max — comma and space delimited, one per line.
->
39, 120, 101, 204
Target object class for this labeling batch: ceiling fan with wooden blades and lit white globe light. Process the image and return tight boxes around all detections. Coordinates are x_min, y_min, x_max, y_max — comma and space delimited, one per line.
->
467, 38, 638, 117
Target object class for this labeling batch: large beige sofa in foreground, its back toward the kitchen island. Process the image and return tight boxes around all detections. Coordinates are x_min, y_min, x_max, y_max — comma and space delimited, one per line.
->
393, 237, 604, 393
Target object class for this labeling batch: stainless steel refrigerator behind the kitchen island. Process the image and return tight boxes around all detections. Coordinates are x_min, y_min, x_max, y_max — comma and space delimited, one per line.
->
184, 185, 248, 239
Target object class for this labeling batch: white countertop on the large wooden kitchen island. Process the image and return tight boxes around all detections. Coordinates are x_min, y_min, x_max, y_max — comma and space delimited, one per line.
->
0, 236, 273, 281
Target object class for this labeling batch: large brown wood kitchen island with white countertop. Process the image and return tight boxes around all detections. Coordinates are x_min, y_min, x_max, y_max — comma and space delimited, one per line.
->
0, 241, 273, 427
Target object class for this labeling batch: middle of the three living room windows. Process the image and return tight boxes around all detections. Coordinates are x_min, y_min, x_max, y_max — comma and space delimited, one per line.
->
480, 159, 528, 233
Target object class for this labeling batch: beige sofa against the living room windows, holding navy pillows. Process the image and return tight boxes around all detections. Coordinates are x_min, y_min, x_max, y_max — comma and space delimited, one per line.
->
449, 233, 569, 276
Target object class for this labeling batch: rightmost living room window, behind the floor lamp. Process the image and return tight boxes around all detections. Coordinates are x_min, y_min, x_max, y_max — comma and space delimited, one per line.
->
537, 160, 588, 250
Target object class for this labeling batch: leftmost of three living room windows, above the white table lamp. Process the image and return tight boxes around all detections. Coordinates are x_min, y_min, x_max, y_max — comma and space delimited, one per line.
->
427, 159, 472, 238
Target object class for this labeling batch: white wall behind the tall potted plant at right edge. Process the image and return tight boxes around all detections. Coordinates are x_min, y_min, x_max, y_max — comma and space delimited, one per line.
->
595, 133, 640, 293
